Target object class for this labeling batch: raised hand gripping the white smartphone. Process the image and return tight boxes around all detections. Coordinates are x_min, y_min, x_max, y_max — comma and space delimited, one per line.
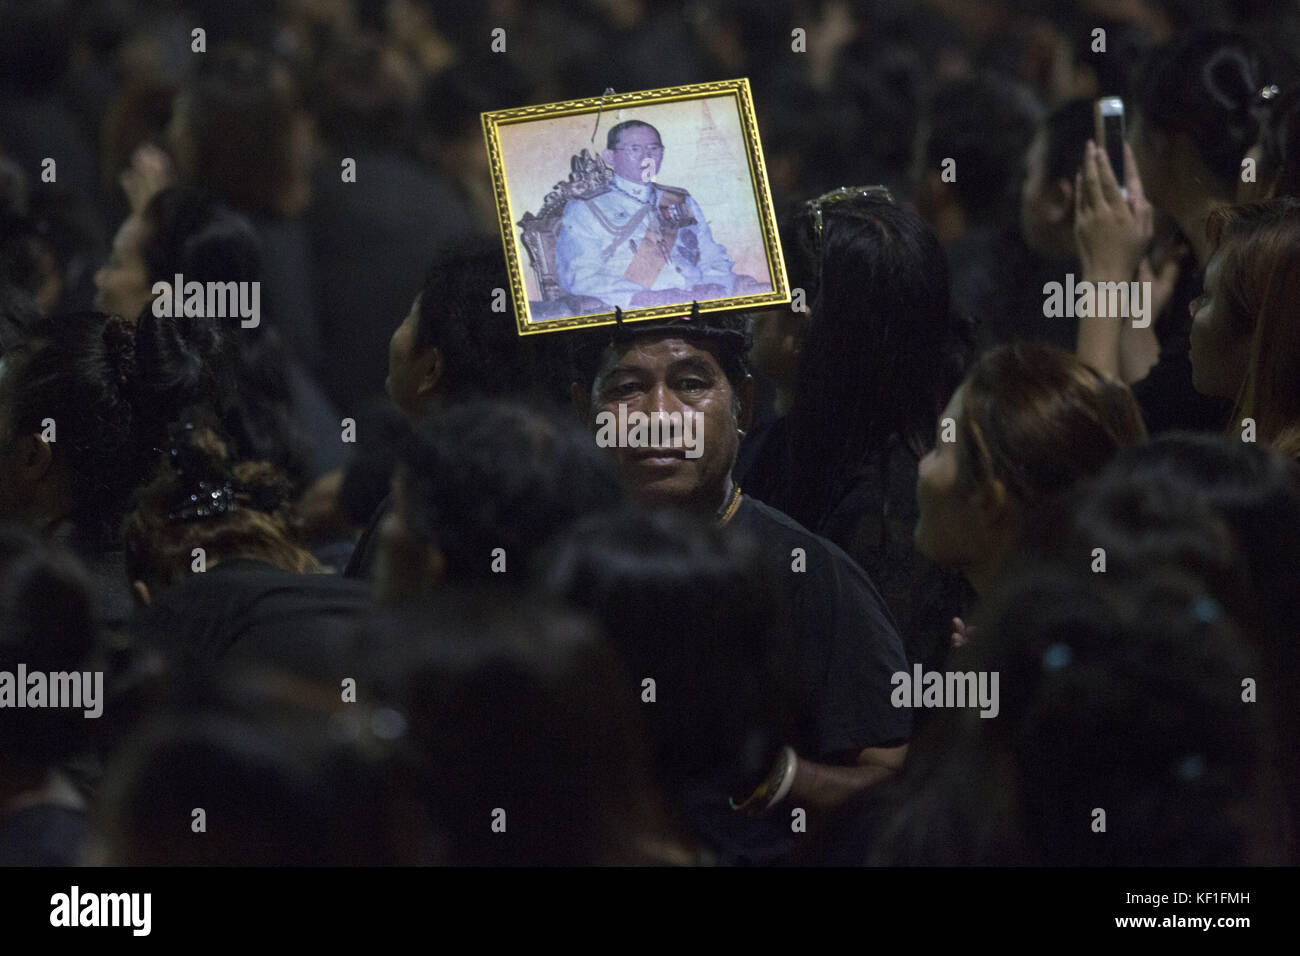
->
1074, 139, 1154, 282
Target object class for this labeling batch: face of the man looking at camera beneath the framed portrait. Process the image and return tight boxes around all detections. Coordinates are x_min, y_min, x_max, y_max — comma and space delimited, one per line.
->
588, 338, 749, 510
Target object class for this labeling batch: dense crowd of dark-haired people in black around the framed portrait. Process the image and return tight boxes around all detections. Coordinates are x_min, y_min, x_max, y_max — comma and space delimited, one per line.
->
0, 0, 1300, 866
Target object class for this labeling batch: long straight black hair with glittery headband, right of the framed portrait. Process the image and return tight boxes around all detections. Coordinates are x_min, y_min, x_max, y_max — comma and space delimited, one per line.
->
774, 195, 952, 531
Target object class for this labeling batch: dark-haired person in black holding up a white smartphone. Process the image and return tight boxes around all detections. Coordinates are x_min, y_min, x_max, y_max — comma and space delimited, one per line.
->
1075, 30, 1268, 432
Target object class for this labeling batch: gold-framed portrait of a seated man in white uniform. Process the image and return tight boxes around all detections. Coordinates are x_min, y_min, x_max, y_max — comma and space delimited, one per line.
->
482, 79, 790, 334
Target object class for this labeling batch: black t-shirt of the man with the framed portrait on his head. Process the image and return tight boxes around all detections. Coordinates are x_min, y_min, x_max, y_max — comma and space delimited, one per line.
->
728, 496, 911, 762
